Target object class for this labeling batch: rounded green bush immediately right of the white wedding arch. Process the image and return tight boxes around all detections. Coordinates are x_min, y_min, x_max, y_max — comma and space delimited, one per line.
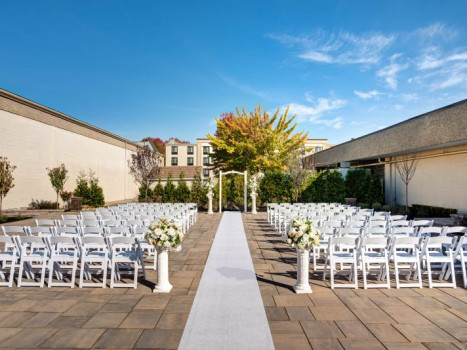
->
259, 171, 294, 203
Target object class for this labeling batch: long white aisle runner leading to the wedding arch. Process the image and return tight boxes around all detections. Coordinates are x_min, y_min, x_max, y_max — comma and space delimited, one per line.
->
179, 212, 274, 350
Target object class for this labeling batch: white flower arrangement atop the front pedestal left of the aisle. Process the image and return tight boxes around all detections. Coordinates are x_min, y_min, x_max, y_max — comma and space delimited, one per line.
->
144, 217, 183, 248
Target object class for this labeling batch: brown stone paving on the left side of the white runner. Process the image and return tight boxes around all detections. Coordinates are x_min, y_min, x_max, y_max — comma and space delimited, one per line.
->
0, 213, 221, 349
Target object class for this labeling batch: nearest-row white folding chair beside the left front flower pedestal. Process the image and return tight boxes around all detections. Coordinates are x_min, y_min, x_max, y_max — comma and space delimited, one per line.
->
109, 237, 146, 289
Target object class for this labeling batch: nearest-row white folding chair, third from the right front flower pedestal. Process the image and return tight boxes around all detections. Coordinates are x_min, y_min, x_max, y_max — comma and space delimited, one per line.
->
388, 237, 423, 289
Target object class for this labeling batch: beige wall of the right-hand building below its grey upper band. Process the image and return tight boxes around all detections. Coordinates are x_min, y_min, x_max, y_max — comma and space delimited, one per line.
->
385, 145, 467, 212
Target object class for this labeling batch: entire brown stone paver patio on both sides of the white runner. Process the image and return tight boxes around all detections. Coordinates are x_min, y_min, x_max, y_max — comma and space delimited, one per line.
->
0, 213, 467, 349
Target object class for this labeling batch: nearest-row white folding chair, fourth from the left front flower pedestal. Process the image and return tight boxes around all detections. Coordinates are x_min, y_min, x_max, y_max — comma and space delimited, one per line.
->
16, 236, 49, 288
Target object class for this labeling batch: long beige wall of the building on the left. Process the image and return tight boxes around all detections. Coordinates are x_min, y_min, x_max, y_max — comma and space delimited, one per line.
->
0, 109, 137, 209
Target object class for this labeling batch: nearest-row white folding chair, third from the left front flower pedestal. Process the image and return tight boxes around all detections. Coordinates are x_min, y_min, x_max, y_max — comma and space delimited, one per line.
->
47, 236, 79, 288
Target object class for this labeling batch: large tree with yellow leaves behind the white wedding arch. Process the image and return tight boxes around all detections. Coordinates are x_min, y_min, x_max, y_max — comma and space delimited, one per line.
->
206, 105, 308, 173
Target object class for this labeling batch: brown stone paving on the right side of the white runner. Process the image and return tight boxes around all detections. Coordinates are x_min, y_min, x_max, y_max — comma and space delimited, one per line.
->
243, 213, 467, 350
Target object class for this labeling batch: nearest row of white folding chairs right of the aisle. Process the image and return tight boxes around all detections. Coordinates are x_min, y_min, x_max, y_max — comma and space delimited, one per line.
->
320, 236, 467, 289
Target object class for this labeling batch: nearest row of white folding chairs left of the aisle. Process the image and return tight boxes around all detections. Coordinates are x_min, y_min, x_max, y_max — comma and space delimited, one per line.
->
0, 236, 146, 288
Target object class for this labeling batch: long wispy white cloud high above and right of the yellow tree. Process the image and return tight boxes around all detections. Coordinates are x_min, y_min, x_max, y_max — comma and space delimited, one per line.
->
268, 30, 395, 64
